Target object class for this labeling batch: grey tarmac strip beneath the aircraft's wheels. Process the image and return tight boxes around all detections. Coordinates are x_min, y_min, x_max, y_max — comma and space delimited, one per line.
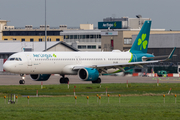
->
0, 75, 180, 85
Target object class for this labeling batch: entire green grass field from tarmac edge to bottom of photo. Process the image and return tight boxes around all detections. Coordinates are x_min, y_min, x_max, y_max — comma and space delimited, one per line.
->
0, 83, 180, 120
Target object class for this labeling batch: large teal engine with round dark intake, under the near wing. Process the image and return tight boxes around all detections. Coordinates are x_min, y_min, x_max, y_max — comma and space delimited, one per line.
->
78, 68, 99, 81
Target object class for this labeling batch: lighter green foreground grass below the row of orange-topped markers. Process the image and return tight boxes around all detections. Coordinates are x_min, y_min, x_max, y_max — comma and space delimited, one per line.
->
0, 95, 180, 120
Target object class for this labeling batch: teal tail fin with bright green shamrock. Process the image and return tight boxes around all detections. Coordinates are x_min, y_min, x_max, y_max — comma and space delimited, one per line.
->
130, 21, 151, 53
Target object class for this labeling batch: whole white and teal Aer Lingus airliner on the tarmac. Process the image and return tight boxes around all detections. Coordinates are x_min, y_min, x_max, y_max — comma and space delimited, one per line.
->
3, 21, 175, 84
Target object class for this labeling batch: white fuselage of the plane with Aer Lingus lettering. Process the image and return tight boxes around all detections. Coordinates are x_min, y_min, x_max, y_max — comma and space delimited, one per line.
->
3, 51, 131, 75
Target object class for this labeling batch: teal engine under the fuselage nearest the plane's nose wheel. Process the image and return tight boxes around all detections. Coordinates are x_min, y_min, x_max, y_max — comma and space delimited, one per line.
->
30, 74, 51, 81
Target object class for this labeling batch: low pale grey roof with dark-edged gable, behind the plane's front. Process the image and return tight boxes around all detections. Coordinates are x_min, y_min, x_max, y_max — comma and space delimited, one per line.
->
0, 41, 78, 53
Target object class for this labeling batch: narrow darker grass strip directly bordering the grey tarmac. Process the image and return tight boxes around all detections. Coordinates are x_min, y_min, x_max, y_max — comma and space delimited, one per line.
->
0, 83, 180, 96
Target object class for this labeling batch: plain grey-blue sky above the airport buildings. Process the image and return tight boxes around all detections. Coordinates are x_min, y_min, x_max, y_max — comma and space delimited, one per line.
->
0, 0, 180, 30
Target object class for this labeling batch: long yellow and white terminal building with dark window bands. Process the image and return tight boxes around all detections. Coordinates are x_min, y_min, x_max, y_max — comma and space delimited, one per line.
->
0, 20, 101, 51
